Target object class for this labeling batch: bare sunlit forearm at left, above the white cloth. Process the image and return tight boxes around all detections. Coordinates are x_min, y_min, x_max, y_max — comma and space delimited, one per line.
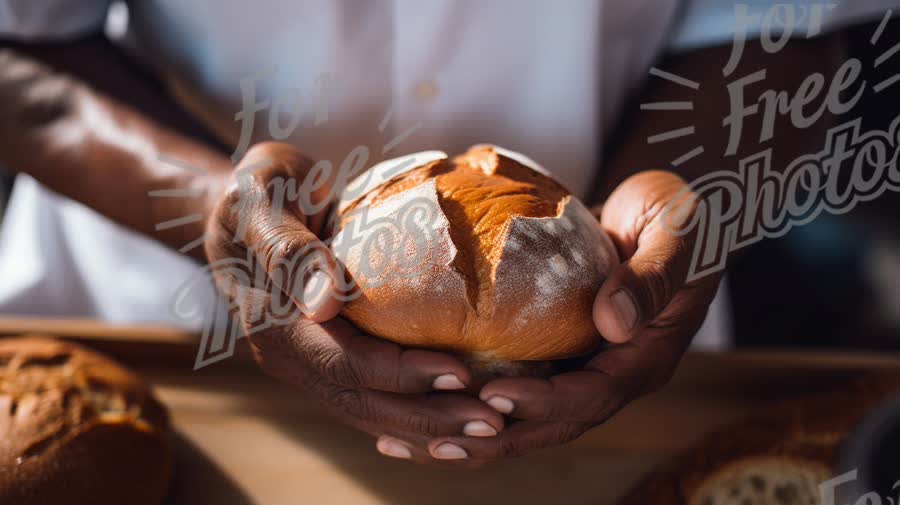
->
0, 37, 231, 259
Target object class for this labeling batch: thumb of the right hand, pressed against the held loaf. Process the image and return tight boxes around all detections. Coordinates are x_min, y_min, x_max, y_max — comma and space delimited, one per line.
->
594, 172, 696, 343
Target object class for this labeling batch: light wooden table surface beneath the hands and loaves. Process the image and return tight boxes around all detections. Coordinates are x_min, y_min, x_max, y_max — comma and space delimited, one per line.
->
0, 318, 900, 505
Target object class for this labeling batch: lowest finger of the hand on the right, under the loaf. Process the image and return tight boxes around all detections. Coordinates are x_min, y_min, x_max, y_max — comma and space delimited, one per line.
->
428, 421, 589, 461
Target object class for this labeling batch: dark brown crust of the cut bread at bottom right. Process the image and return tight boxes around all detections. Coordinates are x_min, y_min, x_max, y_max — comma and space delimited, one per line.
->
619, 374, 900, 505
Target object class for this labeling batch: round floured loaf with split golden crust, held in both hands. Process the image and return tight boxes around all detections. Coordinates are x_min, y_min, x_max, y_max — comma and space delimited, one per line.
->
332, 146, 618, 363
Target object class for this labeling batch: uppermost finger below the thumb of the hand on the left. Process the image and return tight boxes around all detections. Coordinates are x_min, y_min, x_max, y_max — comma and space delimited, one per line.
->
249, 308, 471, 394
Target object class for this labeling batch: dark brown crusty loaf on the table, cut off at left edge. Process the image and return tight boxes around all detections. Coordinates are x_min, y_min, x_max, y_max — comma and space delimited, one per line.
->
0, 337, 173, 505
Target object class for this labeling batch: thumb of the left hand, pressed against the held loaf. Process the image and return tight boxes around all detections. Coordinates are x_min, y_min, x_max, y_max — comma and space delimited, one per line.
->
207, 143, 343, 321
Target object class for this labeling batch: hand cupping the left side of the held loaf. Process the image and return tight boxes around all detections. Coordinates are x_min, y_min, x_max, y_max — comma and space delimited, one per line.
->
206, 143, 503, 461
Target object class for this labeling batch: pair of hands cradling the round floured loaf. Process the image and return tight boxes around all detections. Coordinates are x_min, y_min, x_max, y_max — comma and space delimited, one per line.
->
206, 143, 719, 466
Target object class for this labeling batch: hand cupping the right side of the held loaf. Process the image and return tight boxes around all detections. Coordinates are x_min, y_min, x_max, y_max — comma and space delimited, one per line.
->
428, 171, 719, 463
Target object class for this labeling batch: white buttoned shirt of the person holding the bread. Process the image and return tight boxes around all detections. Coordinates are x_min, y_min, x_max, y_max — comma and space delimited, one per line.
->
0, 0, 892, 344
